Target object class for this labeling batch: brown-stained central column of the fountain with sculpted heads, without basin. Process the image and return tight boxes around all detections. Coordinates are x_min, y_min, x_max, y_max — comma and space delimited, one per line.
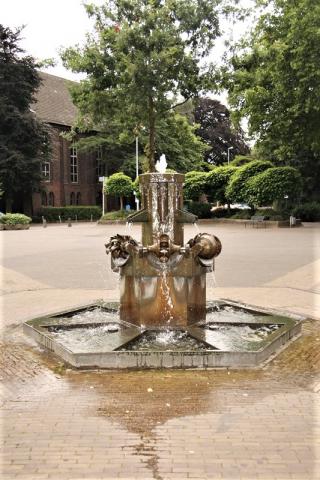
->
106, 173, 221, 328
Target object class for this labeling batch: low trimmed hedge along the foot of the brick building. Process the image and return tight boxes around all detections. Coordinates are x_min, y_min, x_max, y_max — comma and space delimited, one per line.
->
39, 205, 102, 222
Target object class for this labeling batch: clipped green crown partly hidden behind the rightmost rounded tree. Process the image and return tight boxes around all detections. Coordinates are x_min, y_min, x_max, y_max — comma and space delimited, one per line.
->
226, 160, 273, 202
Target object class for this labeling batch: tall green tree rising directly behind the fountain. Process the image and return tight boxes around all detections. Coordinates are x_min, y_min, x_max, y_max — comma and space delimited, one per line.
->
62, 0, 228, 171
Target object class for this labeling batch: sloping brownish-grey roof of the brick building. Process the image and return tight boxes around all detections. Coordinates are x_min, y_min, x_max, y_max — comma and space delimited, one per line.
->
31, 72, 78, 126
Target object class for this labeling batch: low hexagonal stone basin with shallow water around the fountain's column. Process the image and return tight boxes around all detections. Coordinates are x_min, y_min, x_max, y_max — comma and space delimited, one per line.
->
24, 301, 303, 368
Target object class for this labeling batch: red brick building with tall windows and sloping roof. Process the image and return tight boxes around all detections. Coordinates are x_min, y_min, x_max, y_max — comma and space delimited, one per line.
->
30, 72, 105, 214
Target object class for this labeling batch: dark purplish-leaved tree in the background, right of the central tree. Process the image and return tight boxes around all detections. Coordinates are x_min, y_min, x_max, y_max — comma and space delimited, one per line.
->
194, 98, 249, 165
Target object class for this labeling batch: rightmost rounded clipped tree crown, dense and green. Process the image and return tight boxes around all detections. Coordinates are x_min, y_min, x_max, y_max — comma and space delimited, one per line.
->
245, 167, 302, 206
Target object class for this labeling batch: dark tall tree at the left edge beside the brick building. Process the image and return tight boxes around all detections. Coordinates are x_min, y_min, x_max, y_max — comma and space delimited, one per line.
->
0, 25, 48, 212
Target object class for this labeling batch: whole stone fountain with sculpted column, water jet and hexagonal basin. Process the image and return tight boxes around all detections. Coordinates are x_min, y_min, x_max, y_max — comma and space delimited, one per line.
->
24, 168, 302, 368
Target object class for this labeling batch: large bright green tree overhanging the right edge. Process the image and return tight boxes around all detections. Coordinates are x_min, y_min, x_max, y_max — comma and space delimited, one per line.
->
224, 0, 320, 198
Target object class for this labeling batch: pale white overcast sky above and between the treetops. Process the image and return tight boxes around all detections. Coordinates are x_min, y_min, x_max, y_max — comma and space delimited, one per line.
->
0, 0, 252, 110
